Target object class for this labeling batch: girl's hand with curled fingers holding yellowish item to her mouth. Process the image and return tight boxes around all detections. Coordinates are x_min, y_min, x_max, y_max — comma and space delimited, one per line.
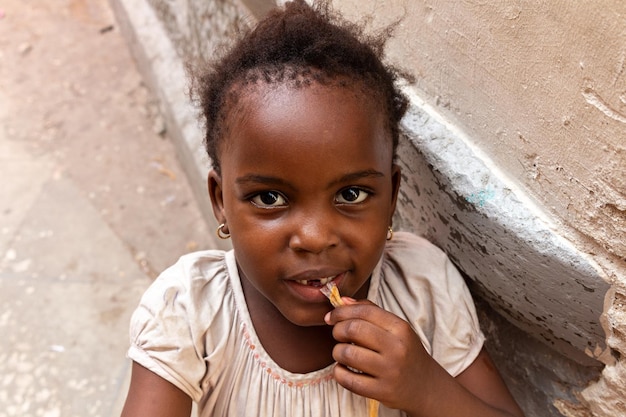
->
326, 297, 434, 412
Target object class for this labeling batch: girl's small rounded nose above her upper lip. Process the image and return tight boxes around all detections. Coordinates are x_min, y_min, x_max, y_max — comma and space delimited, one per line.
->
289, 215, 339, 254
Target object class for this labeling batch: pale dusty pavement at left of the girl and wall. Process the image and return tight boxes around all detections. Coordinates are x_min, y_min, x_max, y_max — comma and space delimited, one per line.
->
0, 0, 214, 417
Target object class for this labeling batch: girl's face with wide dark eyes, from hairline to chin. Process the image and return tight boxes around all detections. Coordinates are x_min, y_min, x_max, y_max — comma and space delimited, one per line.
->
209, 83, 400, 326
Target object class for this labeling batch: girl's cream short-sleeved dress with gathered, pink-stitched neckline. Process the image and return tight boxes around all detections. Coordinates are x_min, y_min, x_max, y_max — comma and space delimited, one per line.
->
128, 232, 484, 417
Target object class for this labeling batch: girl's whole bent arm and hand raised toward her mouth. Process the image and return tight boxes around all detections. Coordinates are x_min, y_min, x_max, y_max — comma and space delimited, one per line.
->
326, 297, 523, 417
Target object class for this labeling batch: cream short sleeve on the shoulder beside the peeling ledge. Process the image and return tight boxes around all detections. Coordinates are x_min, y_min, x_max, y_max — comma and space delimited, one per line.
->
372, 233, 485, 376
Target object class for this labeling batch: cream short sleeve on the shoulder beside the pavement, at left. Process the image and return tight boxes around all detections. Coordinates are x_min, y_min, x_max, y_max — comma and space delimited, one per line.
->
128, 251, 232, 401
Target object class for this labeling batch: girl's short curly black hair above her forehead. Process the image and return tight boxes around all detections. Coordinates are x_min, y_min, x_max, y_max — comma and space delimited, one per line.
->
192, 0, 408, 173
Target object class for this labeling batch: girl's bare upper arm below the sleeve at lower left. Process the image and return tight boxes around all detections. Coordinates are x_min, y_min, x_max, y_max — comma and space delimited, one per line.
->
122, 362, 191, 417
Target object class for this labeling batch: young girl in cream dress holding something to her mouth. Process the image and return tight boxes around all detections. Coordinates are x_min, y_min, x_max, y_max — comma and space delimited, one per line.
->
123, 0, 522, 417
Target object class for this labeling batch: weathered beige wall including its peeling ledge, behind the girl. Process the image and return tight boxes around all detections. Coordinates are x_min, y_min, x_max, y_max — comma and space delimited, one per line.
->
111, 0, 626, 416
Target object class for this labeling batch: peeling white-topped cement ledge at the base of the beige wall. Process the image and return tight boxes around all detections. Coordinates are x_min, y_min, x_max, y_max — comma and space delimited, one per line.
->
398, 87, 610, 365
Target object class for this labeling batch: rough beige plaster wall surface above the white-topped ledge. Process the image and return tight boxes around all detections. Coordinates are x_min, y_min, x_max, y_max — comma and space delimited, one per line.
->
334, 0, 626, 264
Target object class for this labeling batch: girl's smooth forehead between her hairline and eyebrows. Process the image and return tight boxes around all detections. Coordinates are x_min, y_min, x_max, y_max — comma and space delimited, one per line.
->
220, 82, 393, 163
